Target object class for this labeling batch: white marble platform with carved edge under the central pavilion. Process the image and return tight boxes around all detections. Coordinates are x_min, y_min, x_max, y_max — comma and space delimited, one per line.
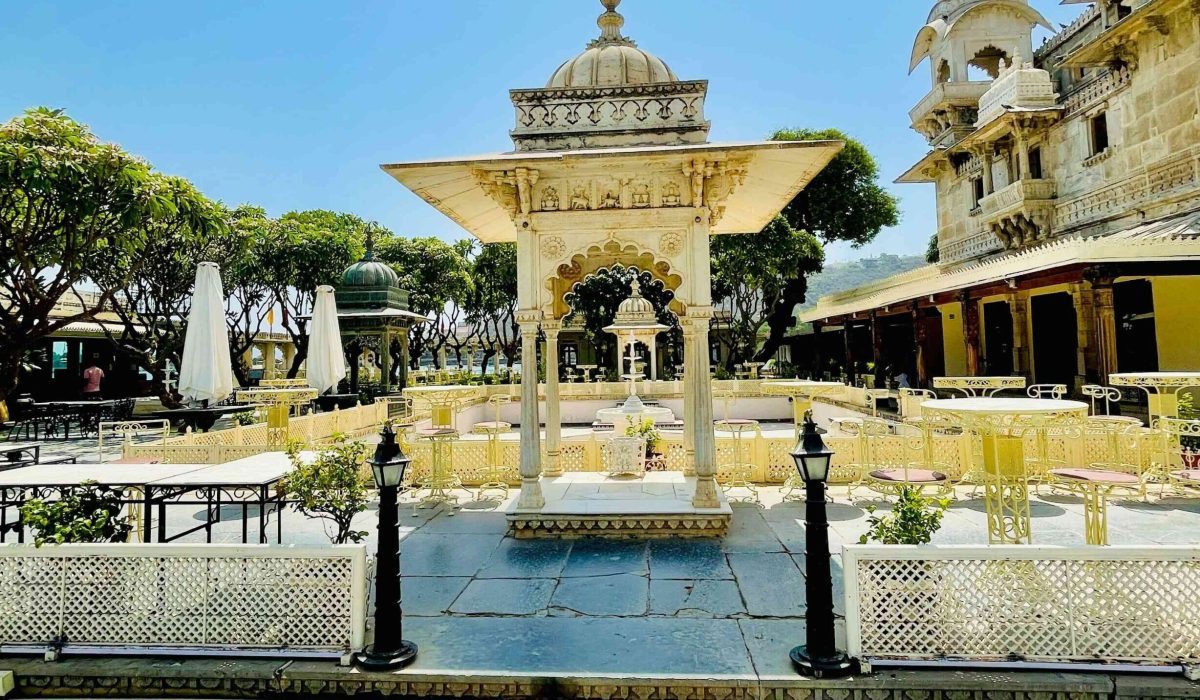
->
506, 472, 733, 538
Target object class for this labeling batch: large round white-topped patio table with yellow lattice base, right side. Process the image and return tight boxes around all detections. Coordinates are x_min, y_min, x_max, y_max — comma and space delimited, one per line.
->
920, 399, 1087, 544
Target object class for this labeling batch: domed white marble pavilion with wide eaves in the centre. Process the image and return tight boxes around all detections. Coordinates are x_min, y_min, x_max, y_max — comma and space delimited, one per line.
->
382, 0, 842, 534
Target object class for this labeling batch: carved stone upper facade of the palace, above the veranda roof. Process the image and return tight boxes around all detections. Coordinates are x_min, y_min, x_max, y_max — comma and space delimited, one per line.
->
900, 0, 1200, 264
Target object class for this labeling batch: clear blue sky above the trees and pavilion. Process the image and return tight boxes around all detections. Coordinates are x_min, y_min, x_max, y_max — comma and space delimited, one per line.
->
0, 0, 1079, 259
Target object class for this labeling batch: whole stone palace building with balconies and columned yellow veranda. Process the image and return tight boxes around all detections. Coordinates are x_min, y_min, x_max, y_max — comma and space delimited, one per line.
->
800, 0, 1200, 391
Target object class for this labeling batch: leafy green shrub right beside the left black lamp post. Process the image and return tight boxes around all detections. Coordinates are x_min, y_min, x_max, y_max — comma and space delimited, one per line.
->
283, 435, 367, 544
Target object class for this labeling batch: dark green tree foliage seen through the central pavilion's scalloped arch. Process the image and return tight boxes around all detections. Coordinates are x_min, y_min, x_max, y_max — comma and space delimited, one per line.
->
563, 264, 682, 367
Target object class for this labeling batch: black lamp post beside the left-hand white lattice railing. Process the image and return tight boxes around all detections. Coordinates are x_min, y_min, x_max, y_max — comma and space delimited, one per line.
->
354, 423, 416, 671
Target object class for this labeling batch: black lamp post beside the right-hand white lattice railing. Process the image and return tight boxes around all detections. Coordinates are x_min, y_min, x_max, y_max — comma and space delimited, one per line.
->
791, 411, 858, 678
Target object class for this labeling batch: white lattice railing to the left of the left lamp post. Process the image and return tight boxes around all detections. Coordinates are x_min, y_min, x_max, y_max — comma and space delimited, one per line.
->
0, 544, 367, 659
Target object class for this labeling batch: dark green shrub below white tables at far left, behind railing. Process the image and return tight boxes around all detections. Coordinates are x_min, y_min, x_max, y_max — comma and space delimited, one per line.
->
20, 481, 133, 546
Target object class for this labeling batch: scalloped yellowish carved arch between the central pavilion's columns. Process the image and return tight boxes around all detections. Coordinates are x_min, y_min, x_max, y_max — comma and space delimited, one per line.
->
542, 239, 685, 318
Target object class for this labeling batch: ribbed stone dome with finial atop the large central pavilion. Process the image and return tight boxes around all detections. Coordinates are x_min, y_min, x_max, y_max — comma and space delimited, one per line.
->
546, 0, 679, 88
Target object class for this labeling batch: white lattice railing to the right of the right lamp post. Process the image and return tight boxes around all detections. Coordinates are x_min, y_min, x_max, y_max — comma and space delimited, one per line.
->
842, 545, 1200, 665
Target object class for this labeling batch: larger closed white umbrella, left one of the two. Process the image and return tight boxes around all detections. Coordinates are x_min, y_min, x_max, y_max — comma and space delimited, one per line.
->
179, 263, 234, 402
